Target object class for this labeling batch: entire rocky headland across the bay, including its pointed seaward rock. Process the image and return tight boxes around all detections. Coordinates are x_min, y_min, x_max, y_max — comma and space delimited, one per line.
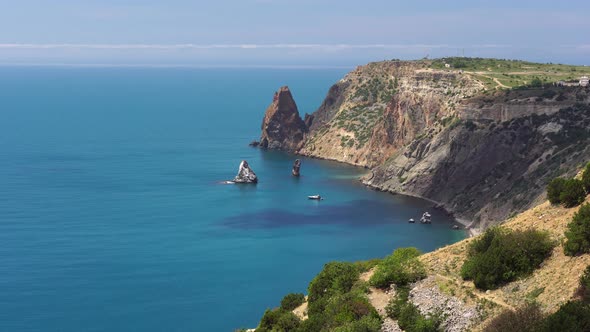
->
262, 59, 590, 227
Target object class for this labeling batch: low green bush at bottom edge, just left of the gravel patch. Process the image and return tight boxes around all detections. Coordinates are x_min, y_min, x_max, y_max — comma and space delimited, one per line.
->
385, 287, 442, 332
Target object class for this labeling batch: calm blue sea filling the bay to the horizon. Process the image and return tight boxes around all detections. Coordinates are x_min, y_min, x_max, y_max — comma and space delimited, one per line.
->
0, 67, 465, 332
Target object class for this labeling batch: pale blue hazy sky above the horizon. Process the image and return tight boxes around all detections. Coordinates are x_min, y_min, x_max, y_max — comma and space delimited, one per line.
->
0, 0, 590, 67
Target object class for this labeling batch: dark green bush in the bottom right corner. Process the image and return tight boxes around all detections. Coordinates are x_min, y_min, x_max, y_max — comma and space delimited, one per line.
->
540, 301, 590, 332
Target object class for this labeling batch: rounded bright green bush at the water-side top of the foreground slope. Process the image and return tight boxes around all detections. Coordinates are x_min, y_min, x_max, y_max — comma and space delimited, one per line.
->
369, 248, 426, 288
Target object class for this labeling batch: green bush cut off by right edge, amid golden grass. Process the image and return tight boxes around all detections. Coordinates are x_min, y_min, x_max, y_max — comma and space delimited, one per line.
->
563, 204, 590, 256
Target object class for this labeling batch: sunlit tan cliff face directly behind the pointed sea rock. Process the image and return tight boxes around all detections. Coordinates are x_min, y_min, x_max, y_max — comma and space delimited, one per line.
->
300, 61, 483, 167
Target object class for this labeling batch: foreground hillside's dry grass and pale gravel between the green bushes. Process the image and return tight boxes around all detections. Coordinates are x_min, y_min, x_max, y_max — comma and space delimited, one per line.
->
252, 197, 590, 332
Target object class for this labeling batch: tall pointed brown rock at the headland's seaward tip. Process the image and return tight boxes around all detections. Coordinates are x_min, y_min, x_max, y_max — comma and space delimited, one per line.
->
260, 86, 307, 152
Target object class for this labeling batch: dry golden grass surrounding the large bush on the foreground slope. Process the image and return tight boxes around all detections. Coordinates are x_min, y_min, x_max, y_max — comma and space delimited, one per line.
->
421, 199, 590, 328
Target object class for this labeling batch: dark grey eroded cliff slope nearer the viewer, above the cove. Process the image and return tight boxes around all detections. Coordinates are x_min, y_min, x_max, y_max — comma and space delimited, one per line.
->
363, 104, 590, 228
